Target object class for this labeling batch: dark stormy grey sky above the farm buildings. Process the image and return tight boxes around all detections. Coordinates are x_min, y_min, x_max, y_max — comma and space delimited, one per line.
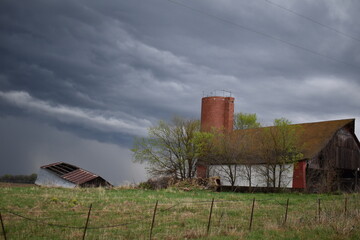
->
0, 0, 360, 184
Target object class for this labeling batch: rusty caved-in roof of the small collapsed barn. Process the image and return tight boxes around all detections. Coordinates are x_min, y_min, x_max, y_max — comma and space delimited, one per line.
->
41, 162, 111, 185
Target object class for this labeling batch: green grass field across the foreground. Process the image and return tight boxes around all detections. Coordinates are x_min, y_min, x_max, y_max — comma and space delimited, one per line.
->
0, 184, 360, 239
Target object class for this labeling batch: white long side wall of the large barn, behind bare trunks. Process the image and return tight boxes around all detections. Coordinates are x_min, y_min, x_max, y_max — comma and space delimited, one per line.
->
209, 164, 294, 188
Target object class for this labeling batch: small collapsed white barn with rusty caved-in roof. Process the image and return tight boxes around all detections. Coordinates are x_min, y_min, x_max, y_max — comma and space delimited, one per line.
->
35, 162, 112, 188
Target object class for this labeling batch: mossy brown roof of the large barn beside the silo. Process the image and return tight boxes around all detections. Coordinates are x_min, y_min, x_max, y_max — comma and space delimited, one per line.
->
235, 119, 359, 162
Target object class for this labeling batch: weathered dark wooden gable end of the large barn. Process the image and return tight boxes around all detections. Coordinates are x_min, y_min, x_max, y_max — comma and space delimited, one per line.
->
306, 122, 360, 192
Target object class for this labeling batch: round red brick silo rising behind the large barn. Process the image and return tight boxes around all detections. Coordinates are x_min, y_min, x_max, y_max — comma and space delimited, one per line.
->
201, 96, 235, 132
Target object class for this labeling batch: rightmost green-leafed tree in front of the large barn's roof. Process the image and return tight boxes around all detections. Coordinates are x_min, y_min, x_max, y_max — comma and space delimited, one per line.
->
260, 118, 303, 188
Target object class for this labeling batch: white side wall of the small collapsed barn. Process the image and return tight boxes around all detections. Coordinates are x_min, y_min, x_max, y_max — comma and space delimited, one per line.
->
35, 168, 76, 188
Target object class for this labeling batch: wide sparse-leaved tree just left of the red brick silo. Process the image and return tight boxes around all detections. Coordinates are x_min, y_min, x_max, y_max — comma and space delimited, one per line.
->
132, 117, 200, 180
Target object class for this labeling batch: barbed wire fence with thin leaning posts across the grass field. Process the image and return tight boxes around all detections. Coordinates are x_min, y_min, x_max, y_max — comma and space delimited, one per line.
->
0, 197, 360, 240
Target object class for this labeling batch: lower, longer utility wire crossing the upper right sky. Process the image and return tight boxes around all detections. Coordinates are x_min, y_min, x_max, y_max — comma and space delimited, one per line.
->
166, 0, 358, 68
